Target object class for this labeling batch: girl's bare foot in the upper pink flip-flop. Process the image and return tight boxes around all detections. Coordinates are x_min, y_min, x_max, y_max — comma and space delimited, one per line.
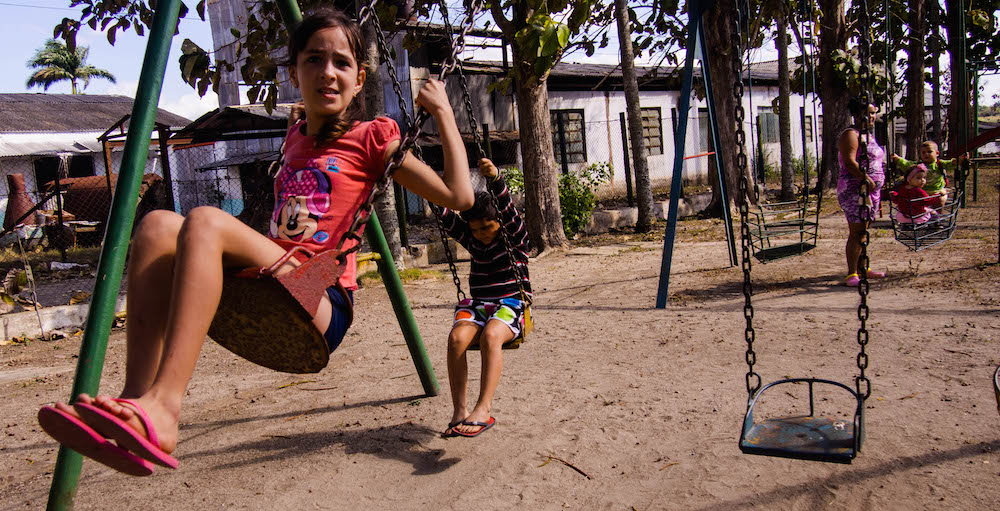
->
71, 394, 179, 461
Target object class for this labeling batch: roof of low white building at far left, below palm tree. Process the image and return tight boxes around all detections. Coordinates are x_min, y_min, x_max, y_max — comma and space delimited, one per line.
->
0, 93, 191, 133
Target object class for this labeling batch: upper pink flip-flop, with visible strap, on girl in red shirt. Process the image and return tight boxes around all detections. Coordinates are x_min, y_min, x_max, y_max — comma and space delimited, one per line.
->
73, 398, 177, 468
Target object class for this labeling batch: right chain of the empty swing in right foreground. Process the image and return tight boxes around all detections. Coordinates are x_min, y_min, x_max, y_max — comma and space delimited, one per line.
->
854, 0, 874, 401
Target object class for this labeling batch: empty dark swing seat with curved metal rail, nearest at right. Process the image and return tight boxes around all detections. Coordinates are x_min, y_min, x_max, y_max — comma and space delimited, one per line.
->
740, 378, 864, 464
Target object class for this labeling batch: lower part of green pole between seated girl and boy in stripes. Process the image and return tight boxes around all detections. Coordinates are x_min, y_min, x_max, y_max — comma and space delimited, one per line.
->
365, 211, 439, 396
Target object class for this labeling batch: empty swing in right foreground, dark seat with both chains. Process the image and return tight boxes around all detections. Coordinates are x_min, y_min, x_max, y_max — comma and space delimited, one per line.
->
733, 3, 871, 463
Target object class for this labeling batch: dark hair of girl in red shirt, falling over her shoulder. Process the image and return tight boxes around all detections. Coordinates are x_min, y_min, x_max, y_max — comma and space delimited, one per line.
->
285, 8, 367, 147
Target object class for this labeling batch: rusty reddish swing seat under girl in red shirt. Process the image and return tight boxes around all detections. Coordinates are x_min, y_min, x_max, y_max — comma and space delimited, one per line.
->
208, 247, 351, 373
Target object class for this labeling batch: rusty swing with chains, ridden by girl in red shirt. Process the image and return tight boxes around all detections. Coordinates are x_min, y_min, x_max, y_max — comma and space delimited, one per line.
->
208, 0, 480, 373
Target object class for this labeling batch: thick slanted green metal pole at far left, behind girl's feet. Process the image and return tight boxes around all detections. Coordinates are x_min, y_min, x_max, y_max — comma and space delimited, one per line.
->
46, 0, 181, 511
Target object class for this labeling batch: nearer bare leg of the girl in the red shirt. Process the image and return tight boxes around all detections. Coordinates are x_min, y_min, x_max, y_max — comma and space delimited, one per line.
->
79, 207, 300, 453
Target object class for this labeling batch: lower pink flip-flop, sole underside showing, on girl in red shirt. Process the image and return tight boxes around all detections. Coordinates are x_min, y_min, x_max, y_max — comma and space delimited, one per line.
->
38, 406, 154, 476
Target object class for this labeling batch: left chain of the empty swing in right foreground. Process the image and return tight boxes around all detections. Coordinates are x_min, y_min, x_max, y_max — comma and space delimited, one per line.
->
730, 0, 761, 399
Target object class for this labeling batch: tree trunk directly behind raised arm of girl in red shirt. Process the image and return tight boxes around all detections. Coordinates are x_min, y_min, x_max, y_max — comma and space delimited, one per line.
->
364, 19, 406, 270
